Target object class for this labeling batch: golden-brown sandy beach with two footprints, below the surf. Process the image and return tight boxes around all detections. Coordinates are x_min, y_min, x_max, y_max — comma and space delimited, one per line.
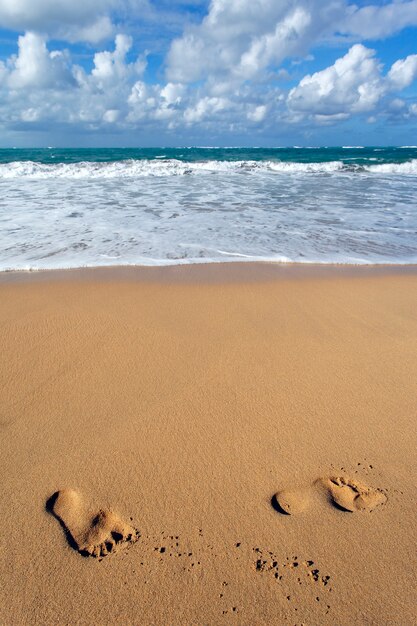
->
0, 265, 417, 626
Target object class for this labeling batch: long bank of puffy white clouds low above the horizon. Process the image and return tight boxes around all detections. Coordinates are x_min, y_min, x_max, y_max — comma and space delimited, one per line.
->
0, 33, 417, 132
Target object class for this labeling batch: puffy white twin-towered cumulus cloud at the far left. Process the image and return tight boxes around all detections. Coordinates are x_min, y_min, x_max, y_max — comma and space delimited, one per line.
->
0, 32, 146, 129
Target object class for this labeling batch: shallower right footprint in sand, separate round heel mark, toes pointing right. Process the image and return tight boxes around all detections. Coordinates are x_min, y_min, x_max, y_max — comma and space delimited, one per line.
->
272, 476, 387, 515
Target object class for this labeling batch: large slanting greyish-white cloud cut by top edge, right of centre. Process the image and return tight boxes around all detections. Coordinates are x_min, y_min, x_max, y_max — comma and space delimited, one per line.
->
167, 0, 344, 82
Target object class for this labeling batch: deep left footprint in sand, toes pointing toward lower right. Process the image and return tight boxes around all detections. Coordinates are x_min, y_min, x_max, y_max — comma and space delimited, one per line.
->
46, 489, 140, 558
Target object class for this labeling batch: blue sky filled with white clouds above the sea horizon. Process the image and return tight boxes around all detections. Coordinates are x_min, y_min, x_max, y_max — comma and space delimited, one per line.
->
0, 0, 417, 147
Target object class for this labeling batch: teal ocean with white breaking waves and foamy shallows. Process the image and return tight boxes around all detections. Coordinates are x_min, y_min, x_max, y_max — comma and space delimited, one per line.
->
0, 146, 417, 270
